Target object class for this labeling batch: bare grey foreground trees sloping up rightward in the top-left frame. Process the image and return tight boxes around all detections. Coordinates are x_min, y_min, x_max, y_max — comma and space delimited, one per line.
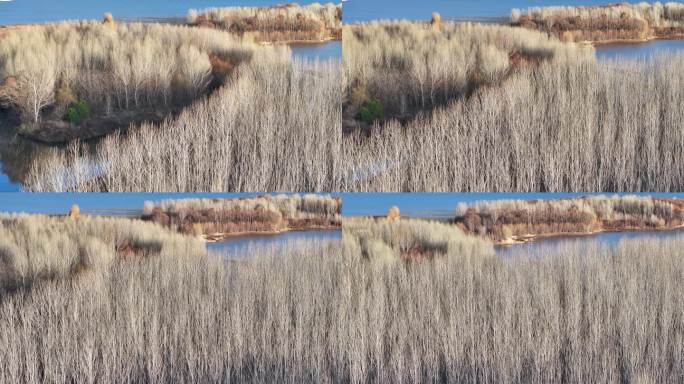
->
24, 59, 342, 192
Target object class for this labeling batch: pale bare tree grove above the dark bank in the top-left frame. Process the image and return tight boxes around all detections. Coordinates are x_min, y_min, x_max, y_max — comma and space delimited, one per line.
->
0, 22, 286, 122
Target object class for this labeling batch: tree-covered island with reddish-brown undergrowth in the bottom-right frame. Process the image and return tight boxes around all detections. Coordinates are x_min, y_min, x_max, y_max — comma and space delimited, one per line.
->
453, 195, 684, 245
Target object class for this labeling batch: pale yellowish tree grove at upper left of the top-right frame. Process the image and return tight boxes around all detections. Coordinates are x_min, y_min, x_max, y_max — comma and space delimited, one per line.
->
343, 21, 593, 116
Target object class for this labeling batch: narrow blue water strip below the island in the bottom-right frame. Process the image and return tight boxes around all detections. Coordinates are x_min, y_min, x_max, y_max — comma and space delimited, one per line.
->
496, 229, 684, 258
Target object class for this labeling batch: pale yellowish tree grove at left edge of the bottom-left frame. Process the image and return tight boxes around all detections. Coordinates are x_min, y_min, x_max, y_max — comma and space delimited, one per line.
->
0, 215, 203, 299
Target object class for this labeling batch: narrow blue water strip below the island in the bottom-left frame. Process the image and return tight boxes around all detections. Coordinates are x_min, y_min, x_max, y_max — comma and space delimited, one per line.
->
207, 230, 342, 258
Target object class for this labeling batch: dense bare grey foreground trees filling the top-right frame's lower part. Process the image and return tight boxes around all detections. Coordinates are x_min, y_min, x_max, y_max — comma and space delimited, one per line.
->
340, 55, 684, 192
